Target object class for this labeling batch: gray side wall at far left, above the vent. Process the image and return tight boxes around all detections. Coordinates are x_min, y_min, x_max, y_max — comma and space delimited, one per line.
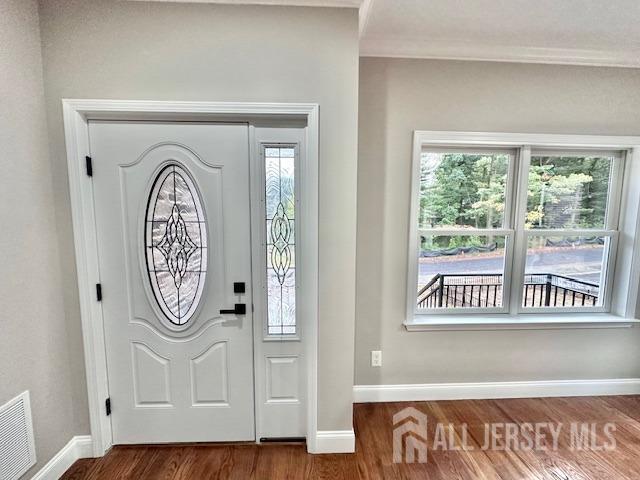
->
0, 0, 78, 473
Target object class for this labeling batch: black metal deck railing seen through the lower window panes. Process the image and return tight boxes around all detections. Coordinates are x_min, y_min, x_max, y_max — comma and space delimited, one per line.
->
418, 273, 600, 308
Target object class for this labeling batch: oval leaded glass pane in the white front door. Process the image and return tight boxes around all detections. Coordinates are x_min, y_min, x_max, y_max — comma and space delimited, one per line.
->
145, 164, 207, 325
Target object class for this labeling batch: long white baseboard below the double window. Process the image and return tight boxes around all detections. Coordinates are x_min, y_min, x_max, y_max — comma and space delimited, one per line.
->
353, 378, 640, 403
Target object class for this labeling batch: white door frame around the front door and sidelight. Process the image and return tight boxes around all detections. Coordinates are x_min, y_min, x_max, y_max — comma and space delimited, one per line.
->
62, 99, 319, 457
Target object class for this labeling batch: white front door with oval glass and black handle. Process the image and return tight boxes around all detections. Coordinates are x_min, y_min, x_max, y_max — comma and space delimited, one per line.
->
89, 121, 255, 444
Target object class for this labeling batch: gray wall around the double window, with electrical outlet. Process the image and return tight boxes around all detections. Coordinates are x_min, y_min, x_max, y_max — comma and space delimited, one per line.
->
355, 58, 640, 385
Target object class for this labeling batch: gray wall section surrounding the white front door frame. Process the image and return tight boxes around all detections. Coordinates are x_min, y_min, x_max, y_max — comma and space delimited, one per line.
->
40, 0, 358, 433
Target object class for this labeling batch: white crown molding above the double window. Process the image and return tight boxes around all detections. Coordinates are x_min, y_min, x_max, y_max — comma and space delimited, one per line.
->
360, 35, 640, 68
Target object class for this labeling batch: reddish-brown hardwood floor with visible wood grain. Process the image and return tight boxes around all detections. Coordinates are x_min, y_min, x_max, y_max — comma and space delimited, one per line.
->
62, 396, 640, 480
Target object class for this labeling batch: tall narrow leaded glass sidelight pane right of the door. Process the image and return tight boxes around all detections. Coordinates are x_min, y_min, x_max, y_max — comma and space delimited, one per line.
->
264, 147, 296, 335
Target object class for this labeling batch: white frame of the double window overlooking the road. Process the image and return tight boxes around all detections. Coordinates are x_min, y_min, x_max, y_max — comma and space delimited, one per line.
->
404, 131, 640, 330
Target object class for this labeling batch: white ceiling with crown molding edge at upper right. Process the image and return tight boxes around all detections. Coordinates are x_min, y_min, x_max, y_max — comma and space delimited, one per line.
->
134, 0, 640, 67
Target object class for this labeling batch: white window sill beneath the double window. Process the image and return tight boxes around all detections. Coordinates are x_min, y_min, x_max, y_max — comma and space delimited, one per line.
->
404, 313, 640, 332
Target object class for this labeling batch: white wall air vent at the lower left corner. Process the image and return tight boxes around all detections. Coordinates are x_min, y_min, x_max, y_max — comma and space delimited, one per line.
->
0, 392, 36, 480
